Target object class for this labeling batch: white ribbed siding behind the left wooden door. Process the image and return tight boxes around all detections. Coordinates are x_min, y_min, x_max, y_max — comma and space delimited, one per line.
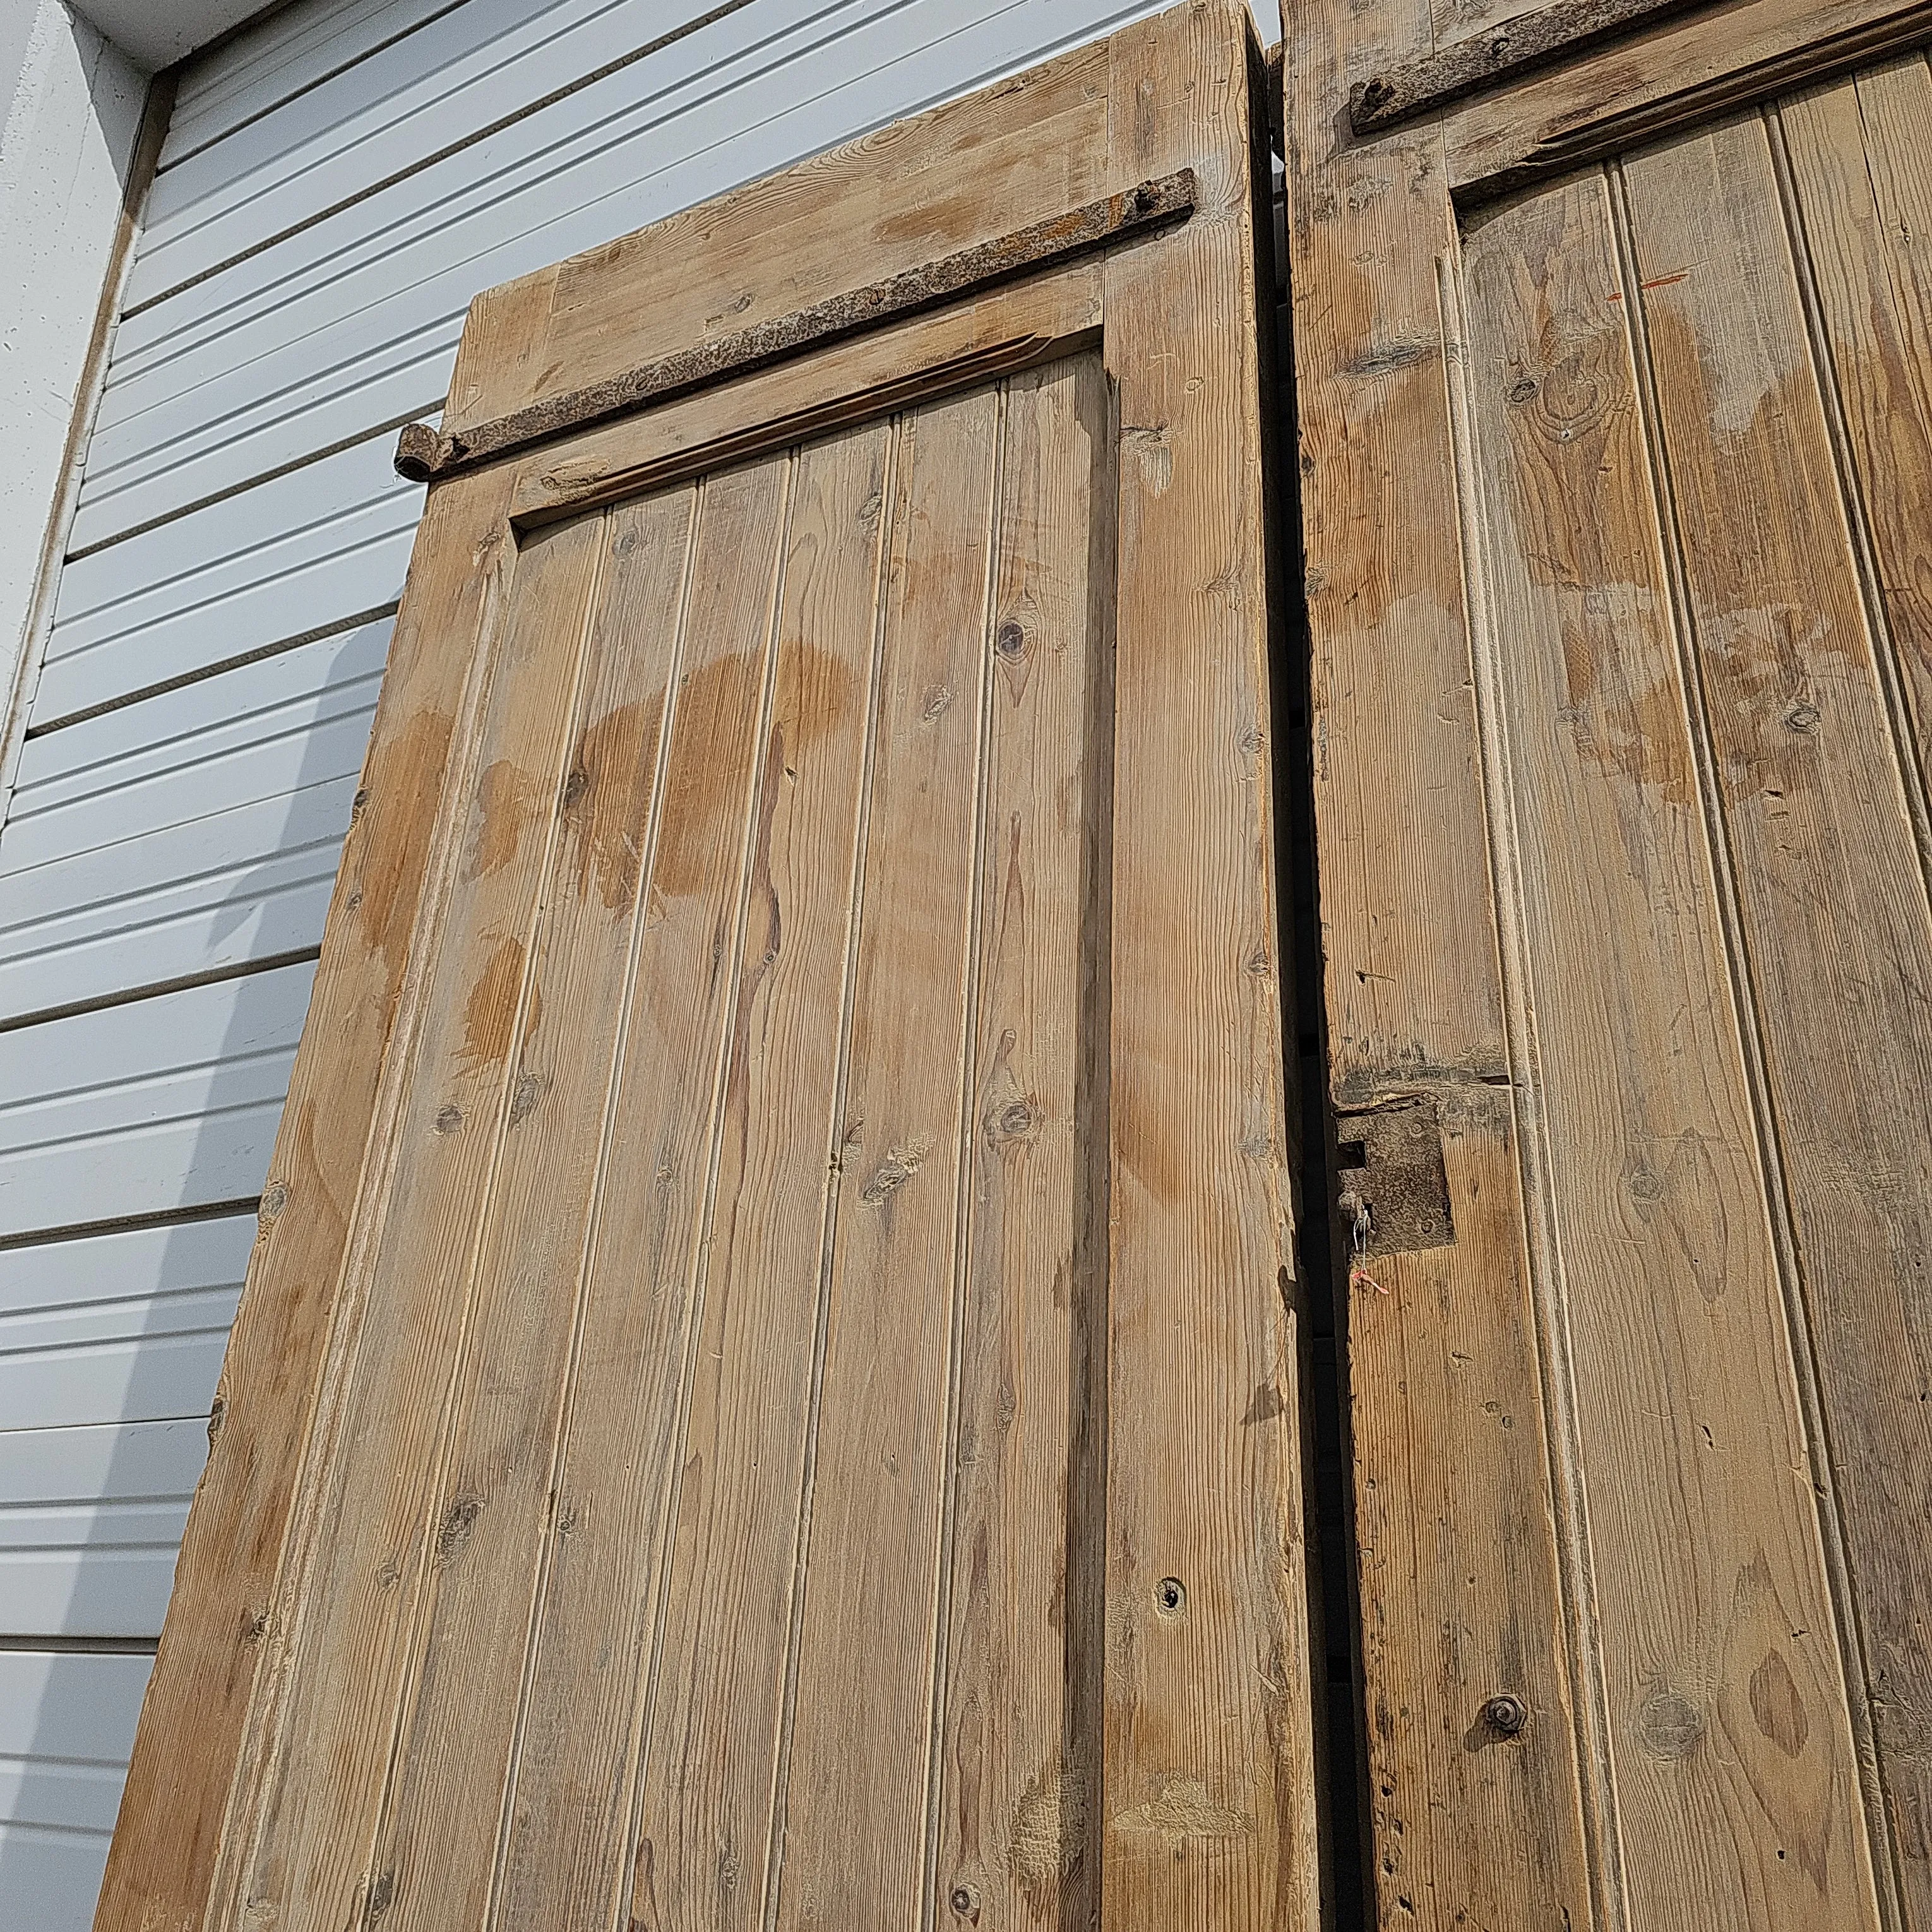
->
0, 0, 1244, 1928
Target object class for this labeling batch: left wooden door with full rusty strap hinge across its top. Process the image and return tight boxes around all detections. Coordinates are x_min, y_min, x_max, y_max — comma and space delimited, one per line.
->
98, 4, 1316, 1932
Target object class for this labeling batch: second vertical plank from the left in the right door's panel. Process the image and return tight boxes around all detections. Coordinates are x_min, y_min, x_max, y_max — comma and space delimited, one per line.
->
1625, 120, 1932, 1924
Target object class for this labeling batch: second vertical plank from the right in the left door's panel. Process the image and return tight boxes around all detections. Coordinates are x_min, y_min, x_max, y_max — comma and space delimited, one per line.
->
773, 390, 1003, 1932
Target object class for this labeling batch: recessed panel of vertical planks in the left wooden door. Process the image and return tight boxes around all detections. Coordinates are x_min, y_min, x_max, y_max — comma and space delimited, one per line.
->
198, 355, 1113, 1926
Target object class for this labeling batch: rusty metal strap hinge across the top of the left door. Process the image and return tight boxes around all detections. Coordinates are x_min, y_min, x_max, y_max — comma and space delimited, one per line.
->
396, 168, 1194, 483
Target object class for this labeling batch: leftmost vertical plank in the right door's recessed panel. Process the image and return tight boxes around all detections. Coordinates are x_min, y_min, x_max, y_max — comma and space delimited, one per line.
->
1464, 174, 1874, 1932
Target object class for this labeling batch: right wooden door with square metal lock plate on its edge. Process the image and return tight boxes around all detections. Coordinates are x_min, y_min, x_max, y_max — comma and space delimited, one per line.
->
1287, 0, 1932, 1932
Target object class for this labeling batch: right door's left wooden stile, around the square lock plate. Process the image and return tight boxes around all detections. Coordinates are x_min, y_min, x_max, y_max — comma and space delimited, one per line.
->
1287, 6, 1602, 1926
